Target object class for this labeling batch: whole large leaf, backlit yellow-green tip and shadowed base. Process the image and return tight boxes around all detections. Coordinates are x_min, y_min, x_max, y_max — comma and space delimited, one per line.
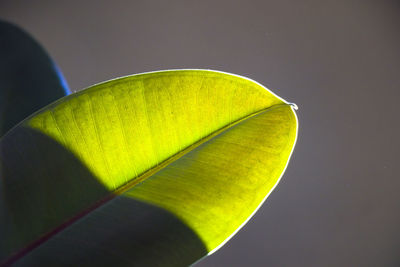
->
0, 70, 297, 266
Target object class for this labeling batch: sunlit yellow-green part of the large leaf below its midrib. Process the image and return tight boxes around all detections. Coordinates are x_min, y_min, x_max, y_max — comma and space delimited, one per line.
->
124, 105, 297, 251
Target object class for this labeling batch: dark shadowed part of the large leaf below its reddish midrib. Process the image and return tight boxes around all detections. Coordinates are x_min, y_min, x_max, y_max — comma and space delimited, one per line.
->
15, 197, 207, 267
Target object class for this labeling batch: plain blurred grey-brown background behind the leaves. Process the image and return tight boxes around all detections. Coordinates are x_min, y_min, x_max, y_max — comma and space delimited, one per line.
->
0, 0, 400, 266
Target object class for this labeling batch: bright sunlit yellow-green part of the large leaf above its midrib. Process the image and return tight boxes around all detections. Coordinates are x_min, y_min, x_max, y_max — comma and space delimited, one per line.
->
26, 70, 282, 190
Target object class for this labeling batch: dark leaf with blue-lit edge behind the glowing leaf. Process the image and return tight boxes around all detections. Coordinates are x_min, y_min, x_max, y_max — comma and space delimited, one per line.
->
0, 20, 69, 136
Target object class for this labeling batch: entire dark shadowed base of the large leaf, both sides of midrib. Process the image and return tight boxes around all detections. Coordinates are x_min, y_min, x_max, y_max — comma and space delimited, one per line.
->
0, 126, 207, 266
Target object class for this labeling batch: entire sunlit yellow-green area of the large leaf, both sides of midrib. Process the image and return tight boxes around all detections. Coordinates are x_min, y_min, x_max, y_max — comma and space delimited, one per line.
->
14, 70, 297, 256
